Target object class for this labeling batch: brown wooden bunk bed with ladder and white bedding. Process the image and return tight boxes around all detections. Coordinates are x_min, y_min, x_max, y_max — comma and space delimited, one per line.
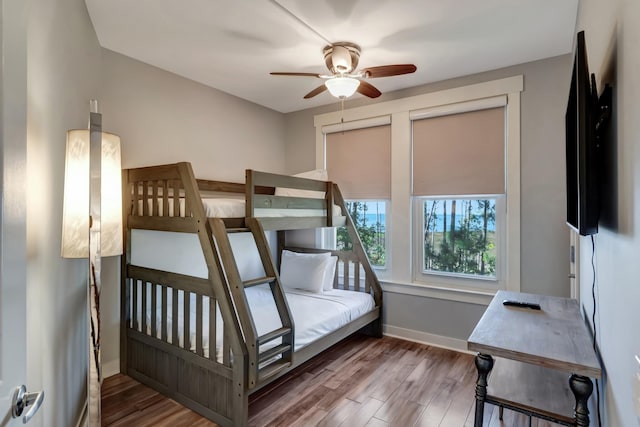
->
120, 163, 382, 426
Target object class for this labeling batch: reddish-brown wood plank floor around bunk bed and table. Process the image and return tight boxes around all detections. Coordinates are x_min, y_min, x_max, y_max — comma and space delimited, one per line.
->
102, 335, 555, 427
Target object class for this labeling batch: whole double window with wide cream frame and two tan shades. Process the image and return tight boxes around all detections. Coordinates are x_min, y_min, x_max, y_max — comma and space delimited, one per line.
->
314, 76, 524, 304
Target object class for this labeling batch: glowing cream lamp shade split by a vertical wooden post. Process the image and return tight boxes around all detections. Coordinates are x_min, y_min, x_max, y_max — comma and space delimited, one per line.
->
62, 129, 122, 258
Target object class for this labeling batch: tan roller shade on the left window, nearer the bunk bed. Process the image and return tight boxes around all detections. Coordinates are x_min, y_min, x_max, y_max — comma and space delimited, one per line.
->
326, 125, 391, 199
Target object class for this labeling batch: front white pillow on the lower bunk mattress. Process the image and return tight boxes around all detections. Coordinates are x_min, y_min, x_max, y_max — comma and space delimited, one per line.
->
280, 250, 331, 293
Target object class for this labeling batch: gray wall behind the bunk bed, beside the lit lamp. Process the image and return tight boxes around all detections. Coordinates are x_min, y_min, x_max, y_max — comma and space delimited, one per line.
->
100, 49, 285, 375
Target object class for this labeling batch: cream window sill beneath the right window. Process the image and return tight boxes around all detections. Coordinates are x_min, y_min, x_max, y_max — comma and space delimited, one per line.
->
380, 280, 496, 305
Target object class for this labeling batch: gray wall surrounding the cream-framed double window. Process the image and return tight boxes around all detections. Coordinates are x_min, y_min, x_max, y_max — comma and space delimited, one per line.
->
286, 55, 572, 340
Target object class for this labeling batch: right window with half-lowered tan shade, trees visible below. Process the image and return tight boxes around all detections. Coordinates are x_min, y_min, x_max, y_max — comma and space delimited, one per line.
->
412, 107, 506, 287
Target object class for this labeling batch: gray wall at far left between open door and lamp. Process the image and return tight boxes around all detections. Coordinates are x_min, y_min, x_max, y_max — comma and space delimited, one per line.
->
26, 0, 101, 427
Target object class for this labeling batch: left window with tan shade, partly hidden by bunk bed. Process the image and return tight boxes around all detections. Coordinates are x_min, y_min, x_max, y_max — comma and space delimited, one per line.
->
325, 124, 391, 267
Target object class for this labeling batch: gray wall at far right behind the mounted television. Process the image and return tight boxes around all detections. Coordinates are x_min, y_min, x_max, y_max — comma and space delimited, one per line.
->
578, 0, 640, 427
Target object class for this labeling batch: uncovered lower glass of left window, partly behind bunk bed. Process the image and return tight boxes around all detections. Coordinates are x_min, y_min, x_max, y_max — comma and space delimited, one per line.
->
336, 200, 387, 267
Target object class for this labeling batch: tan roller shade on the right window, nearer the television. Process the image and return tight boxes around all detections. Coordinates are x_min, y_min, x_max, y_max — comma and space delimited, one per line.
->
413, 107, 505, 196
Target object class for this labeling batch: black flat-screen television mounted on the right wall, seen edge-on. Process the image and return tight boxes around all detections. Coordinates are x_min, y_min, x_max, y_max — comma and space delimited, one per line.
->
565, 31, 611, 236
